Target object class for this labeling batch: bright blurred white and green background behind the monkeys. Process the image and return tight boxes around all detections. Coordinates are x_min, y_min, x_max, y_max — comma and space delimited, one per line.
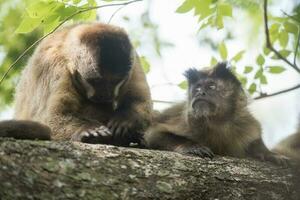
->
0, 0, 300, 147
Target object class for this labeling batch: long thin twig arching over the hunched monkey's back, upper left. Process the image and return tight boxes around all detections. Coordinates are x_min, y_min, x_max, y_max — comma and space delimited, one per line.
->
0, 0, 143, 85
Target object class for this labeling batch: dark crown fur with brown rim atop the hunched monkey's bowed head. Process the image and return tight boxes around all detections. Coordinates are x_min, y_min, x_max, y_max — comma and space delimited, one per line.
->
81, 24, 133, 74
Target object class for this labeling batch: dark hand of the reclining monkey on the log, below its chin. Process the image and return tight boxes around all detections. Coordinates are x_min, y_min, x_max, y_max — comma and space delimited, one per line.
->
174, 144, 214, 159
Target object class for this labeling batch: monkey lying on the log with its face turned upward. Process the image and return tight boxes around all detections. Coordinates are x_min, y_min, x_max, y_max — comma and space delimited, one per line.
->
144, 63, 287, 165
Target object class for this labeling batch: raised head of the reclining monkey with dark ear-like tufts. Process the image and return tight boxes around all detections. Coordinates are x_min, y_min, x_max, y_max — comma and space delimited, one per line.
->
184, 63, 247, 119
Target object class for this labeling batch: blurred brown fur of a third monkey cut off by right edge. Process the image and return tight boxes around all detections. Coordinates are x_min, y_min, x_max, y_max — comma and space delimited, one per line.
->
273, 123, 300, 161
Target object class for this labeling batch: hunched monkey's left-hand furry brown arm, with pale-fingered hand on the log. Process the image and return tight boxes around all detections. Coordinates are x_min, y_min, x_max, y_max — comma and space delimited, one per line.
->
45, 74, 111, 143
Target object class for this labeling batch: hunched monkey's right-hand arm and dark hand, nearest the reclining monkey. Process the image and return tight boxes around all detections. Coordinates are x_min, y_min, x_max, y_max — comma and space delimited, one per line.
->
107, 58, 152, 145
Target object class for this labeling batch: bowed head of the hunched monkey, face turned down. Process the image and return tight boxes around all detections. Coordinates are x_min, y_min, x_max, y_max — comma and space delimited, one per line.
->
71, 24, 135, 106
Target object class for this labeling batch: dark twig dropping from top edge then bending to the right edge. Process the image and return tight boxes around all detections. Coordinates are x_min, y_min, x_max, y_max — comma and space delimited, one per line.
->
264, 0, 300, 74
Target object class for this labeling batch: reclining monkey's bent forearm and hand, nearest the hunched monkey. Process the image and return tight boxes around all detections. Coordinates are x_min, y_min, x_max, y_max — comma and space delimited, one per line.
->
144, 123, 214, 158
